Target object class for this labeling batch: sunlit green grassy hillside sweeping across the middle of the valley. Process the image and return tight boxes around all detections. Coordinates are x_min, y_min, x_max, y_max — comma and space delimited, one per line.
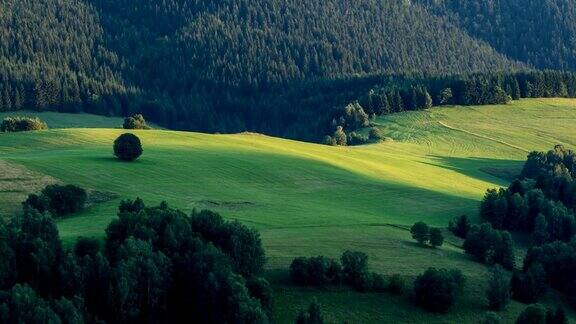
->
0, 99, 576, 323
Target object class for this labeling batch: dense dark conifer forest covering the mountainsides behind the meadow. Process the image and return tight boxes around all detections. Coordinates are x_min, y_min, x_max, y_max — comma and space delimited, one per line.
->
0, 0, 576, 137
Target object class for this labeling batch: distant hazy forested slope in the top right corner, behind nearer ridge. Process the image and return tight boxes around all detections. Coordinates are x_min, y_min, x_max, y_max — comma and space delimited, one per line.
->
415, 0, 576, 70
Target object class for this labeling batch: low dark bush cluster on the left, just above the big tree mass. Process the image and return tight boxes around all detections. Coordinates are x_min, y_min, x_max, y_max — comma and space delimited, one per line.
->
23, 184, 88, 217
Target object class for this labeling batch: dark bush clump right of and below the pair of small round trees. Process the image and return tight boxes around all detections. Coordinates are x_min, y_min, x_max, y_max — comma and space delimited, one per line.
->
464, 223, 515, 270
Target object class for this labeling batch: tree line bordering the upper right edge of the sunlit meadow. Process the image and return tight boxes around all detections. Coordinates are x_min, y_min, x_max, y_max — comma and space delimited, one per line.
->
324, 71, 576, 145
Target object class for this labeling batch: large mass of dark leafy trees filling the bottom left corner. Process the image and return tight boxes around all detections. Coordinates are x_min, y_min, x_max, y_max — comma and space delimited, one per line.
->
0, 200, 272, 323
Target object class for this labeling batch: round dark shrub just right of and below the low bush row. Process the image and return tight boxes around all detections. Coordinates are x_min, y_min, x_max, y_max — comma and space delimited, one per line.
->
414, 268, 464, 313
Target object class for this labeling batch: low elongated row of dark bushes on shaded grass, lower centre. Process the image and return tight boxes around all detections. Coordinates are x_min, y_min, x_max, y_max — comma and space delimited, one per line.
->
290, 251, 404, 294
